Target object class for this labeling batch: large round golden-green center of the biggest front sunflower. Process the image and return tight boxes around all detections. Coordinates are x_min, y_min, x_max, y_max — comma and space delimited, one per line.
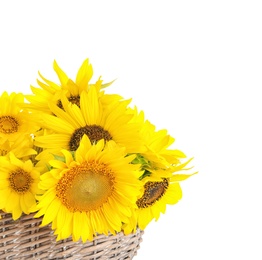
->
56, 162, 114, 212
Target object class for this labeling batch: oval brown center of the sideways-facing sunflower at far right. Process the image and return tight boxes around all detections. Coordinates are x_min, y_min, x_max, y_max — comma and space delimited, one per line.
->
136, 179, 168, 208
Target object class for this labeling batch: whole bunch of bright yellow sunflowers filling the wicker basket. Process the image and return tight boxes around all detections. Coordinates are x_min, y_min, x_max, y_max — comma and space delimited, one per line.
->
0, 59, 194, 252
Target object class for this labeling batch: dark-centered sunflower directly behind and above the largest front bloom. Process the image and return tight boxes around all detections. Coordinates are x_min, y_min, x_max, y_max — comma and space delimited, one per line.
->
35, 87, 143, 157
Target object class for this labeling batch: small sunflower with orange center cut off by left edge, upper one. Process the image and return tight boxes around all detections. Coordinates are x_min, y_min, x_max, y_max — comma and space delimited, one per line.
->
0, 92, 38, 145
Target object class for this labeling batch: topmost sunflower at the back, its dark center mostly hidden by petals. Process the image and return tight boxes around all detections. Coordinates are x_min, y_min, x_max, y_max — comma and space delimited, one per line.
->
26, 59, 116, 113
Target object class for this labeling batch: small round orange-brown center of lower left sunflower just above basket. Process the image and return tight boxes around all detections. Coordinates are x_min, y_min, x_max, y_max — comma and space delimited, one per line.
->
9, 169, 33, 193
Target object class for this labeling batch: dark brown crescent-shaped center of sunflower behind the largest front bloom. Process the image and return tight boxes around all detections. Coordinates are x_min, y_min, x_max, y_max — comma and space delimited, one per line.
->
69, 125, 112, 151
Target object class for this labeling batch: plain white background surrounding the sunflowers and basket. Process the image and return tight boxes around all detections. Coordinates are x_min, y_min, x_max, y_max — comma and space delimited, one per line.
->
0, 0, 262, 260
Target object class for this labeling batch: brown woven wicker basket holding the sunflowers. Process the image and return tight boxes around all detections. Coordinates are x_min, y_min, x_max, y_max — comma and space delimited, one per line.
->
0, 212, 143, 260
